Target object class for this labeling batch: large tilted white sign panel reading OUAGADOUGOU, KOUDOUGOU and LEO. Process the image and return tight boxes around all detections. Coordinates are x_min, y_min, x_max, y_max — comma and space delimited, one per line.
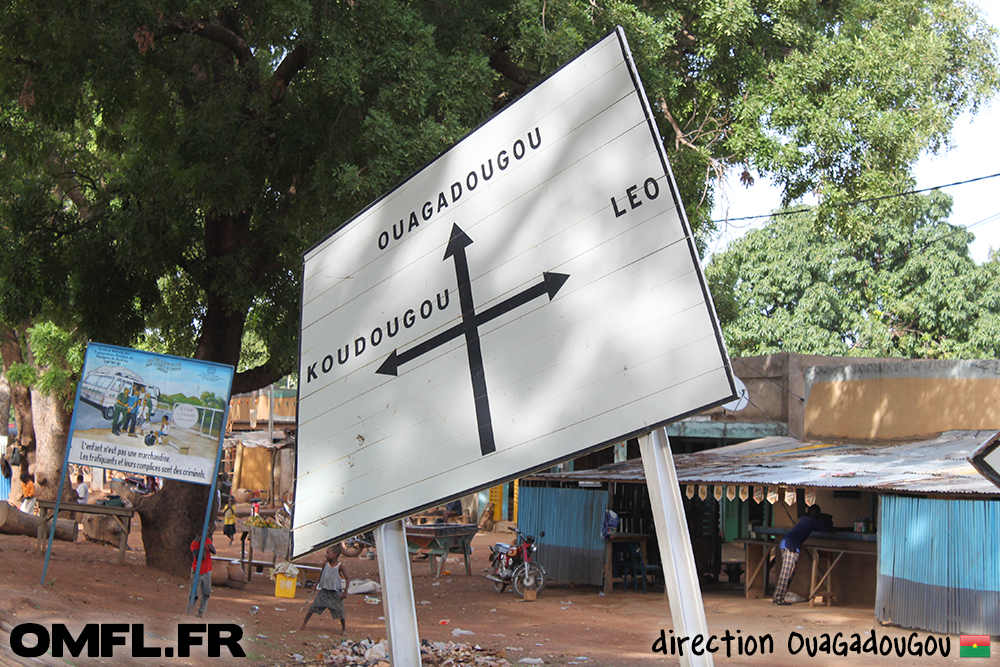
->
294, 30, 735, 555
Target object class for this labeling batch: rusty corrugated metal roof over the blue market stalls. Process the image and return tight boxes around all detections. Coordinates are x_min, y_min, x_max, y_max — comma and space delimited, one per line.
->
529, 431, 998, 495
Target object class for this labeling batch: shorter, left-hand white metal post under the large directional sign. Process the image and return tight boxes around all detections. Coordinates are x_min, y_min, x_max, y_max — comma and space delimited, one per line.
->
375, 520, 420, 667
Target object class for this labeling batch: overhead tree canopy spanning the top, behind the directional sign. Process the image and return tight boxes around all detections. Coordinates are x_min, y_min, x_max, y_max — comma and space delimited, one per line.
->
0, 0, 997, 569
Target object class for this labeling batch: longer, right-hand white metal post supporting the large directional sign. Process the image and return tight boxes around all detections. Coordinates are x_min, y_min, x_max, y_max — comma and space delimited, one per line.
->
639, 428, 715, 667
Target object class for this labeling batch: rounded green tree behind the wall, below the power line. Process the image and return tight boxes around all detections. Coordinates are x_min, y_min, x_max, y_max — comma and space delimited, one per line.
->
705, 192, 1000, 358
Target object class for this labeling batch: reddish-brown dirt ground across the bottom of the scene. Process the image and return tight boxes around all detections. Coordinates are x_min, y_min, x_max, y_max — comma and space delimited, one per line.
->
0, 508, 988, 667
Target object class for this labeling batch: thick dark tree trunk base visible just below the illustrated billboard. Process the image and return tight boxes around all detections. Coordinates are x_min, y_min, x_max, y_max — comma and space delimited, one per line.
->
138, 479, 218, 577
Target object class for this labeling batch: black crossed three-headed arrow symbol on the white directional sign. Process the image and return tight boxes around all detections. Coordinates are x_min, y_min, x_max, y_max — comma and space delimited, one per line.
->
375, 225, 569, 455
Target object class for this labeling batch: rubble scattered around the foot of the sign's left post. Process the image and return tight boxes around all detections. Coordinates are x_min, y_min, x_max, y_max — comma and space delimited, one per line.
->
273, 639, 511, 667
